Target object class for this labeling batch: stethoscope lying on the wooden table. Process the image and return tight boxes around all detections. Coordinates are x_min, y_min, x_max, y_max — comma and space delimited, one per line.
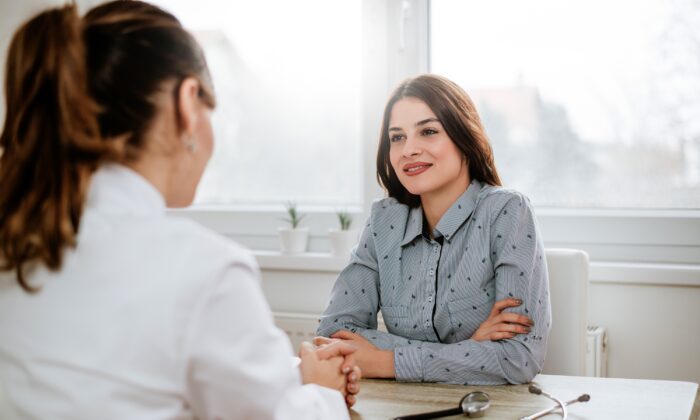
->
393, 385, 591, 420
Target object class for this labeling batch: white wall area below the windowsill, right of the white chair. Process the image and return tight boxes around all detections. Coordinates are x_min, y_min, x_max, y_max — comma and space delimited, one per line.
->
588, 282, 700, 383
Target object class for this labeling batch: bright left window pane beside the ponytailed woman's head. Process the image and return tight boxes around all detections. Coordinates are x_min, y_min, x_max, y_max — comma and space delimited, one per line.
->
157, 0, 361, 205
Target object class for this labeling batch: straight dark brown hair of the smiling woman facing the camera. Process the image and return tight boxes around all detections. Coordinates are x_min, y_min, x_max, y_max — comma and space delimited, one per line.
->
377, 74, 501, 207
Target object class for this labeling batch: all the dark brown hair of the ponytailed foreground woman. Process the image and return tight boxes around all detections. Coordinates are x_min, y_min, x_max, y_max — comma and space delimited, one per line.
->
0, 1, 215, 292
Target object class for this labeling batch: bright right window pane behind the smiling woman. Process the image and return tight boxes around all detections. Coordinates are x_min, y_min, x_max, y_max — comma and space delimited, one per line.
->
430, 0, 700, 208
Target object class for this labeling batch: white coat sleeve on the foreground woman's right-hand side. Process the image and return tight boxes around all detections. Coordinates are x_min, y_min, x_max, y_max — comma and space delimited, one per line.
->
183, 263, 348, 419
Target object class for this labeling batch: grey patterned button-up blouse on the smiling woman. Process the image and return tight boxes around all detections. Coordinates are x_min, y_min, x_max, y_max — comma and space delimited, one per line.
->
318, 181, 551, 385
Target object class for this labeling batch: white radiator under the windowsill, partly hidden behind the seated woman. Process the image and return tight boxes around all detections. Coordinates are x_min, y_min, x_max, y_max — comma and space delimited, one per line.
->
274, 312, 608, 377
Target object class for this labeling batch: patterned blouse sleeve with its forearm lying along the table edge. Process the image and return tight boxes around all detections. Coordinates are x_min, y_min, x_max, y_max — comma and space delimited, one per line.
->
394, 195, 551, 385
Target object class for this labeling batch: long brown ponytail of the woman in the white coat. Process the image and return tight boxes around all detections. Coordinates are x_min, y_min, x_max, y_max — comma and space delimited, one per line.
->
0, 5, 114, 291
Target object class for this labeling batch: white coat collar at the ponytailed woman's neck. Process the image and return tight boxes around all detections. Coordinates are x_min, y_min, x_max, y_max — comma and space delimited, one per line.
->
85, 163, 165, 215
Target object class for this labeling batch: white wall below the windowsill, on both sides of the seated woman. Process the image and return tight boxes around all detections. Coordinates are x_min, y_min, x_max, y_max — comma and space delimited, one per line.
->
257, 253, 700, 383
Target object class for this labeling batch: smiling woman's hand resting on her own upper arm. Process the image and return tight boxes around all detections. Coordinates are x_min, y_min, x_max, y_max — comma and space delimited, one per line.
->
471, 299, 533, 341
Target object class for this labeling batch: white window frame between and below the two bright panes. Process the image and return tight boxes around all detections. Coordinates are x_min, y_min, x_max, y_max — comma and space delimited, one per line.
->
171, 0, 700, 270
